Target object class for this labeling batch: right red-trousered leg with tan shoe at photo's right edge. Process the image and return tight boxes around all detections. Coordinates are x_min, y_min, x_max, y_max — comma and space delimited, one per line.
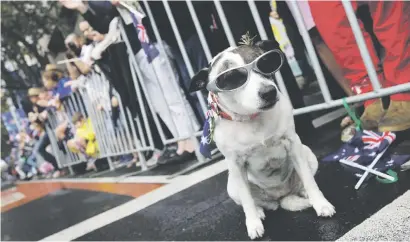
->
369, 1, 410, 131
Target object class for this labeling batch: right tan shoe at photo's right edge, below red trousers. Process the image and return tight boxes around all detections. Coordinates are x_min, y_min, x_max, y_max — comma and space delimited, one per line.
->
379, 101, 410, 132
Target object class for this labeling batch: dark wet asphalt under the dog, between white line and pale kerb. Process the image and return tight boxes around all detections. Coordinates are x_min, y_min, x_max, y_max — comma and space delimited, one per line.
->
77, 164, 410, 241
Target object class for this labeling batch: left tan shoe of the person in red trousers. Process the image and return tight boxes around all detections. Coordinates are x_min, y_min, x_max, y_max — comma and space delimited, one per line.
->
360, 98, 386, 130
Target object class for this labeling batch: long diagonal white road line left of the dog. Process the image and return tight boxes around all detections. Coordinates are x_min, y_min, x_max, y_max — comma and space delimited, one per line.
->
40, 160, 227, 241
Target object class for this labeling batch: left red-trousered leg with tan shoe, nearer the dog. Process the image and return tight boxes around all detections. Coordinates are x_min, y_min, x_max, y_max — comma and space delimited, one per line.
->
309, 1, 384, 129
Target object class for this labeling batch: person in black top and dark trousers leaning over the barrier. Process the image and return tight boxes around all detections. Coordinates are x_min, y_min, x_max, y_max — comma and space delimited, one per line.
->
60, 0, 163, 163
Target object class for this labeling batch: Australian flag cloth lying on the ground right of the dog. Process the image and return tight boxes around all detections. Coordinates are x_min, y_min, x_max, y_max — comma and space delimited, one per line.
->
322, 130, 410, 177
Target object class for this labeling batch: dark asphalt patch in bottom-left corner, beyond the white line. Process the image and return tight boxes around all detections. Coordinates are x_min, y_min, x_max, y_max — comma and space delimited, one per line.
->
1, 189, 132, 241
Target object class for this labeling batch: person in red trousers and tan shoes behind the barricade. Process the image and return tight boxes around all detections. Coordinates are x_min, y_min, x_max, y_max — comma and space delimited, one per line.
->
309, 1, 410, 131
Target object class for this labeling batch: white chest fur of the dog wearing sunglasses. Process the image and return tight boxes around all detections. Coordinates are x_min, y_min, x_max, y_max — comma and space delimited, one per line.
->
214, 100, 293, 189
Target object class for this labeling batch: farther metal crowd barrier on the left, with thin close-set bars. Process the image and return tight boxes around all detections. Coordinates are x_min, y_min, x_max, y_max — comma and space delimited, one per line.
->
46, 71, 153, 173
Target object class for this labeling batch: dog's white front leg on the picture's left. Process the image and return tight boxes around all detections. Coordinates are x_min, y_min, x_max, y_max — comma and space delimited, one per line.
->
228, 161, 265, 239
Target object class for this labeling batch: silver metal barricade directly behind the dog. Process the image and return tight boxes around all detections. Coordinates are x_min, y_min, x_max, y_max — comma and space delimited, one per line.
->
122, 0, 410, 178
